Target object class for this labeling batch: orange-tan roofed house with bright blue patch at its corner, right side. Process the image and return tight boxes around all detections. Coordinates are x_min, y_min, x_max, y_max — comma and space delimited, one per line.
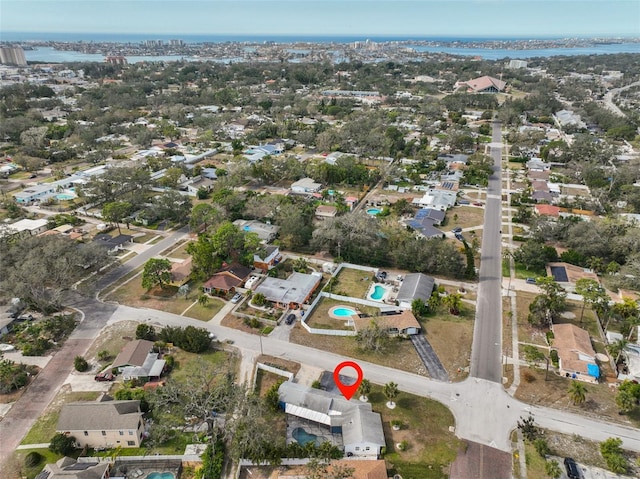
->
551, 324, 600, 383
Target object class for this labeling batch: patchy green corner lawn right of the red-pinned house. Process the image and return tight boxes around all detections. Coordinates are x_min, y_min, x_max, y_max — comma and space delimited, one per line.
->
369, 386, 462, 479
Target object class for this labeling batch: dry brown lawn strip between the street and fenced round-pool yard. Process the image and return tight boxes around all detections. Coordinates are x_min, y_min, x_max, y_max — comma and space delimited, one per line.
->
289, 324, 427, 376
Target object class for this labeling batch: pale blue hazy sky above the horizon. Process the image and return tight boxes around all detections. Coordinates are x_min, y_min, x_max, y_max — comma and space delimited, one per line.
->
0, 0, 640, 40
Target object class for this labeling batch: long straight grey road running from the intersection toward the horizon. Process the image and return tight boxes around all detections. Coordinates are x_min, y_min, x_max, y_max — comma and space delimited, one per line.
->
471, 122, 502, 383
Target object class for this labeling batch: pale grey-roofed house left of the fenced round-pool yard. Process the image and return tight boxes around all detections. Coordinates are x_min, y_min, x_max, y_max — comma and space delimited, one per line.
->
255, 272, 322, 309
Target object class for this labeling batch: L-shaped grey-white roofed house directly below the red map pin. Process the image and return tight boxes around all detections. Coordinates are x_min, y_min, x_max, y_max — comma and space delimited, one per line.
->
278, 381, 385, 458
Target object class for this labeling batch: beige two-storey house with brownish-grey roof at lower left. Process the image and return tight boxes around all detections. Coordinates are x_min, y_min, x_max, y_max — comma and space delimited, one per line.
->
56, 400, 144, 449
